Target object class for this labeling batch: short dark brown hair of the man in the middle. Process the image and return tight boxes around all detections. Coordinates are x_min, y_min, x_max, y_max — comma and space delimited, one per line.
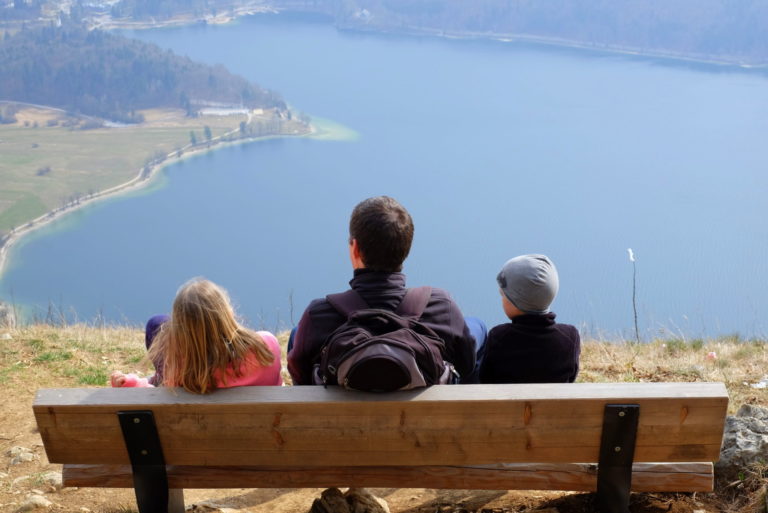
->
349, 196, 413, 272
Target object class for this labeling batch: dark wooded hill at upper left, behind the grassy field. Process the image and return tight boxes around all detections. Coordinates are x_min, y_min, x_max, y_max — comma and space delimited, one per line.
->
0, 27, 285, 122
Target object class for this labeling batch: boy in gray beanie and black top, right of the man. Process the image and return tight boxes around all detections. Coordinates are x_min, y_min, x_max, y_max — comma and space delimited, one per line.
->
480, 255, 581, 383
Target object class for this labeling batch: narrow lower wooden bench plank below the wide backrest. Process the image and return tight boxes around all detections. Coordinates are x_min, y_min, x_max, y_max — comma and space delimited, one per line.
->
63, 463, 713, 492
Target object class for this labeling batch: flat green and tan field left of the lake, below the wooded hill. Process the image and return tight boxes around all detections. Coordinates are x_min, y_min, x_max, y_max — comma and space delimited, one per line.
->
0, 108, 304, 235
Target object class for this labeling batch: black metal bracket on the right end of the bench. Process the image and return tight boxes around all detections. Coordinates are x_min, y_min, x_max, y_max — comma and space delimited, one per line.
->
597, 404, 640, 513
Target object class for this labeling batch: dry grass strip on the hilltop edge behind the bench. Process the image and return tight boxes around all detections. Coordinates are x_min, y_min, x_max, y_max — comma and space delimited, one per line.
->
0, 324, 768, 406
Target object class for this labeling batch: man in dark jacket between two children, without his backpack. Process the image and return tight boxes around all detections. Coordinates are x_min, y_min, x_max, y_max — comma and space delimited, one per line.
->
288, 196, 485, 385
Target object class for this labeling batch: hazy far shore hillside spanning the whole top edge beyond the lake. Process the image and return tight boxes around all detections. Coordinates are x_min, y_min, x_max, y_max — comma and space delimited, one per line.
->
6, 0, 768, 65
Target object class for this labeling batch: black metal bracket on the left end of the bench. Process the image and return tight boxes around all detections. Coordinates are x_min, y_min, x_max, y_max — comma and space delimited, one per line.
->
117, 410, 184, 513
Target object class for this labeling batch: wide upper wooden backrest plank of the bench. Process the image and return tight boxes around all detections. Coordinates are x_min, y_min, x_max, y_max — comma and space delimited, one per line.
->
34, 383, 728, 467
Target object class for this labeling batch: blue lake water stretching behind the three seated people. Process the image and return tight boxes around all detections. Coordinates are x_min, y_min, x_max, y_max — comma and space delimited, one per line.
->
0, 16, 768, 339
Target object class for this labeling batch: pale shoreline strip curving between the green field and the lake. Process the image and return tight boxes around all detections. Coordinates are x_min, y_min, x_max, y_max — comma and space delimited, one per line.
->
0, 112, 318, 280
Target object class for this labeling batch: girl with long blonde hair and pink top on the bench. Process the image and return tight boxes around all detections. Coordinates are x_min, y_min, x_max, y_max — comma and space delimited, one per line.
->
111, 278, 282, 394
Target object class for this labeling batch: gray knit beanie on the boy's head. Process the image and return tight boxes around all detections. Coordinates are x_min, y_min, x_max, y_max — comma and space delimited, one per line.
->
496, 255, 560, 313
